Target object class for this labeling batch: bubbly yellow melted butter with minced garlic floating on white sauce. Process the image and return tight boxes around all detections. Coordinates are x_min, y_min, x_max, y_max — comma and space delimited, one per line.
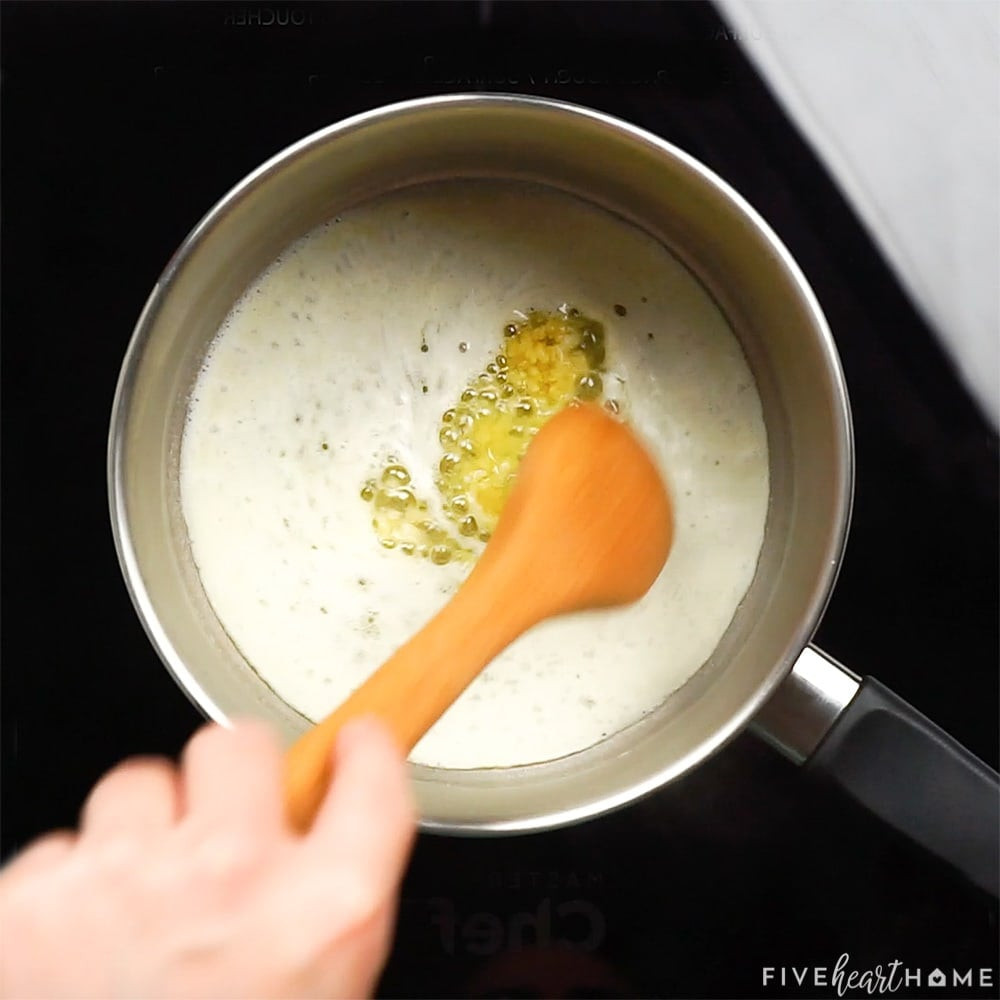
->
361, 306, 619, 565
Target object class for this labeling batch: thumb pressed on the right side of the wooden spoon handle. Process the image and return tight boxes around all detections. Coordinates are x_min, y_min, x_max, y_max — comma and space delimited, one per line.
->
307, 718, 415, 895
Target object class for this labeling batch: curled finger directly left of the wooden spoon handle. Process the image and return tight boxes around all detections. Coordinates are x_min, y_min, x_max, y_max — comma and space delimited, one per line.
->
181, 720, 284, 836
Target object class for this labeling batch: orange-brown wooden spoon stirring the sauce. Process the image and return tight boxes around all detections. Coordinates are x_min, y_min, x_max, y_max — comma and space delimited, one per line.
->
285, 404, 673, 830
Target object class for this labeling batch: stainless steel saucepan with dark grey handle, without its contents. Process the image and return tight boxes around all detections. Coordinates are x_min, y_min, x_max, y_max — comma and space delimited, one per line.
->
108, 94, 998, 892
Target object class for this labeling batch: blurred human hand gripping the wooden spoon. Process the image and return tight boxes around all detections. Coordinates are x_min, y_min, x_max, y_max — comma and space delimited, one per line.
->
0, 719, 415, 1000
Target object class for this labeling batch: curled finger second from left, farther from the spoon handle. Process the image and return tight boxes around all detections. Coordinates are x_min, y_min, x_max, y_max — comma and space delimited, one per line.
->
80, 758, 180, 845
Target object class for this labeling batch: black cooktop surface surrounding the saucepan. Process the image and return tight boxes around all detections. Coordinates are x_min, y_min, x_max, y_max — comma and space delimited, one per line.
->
2, 2, 998, 997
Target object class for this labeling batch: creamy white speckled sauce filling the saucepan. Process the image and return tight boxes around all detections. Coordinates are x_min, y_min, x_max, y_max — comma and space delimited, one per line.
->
180, 182, 768, 768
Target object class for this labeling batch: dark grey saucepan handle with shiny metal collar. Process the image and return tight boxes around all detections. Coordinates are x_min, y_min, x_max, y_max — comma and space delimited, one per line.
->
755, 647, 1000, 896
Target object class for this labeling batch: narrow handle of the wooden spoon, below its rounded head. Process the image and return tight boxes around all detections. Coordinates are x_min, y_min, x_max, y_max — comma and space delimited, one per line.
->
285, 561, 532, 831
